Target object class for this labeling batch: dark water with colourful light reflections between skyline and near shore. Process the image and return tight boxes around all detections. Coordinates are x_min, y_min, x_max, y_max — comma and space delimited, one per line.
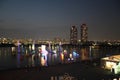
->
0, 46, 120, 70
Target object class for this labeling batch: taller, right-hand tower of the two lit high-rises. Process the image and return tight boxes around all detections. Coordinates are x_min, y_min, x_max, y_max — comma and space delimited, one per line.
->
81, 24, 88, 42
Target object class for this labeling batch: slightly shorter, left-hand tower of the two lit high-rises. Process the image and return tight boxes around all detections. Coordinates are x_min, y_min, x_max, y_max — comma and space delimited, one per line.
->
70, 26, 78, 44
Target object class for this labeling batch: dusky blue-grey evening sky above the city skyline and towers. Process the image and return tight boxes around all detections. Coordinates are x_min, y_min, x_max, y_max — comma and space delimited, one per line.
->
0, 0, 120, 40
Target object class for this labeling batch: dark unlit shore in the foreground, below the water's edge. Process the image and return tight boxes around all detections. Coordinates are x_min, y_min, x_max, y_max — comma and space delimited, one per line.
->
0, 62, 120, 80
